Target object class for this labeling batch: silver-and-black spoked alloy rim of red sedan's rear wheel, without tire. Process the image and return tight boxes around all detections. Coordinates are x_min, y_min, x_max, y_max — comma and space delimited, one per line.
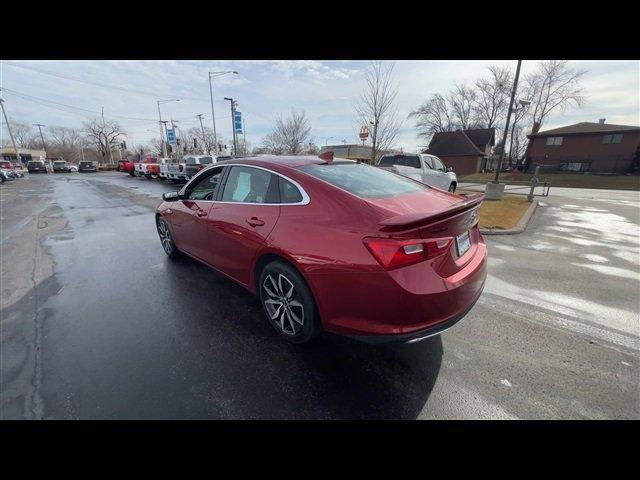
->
262, 273, 304, 335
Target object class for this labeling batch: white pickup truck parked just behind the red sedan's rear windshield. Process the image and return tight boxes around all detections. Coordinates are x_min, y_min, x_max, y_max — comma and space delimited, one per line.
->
378, 153, 458, 193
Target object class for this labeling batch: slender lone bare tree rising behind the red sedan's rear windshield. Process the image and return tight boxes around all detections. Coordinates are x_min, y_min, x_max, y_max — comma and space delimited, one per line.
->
355, 61, 402, 163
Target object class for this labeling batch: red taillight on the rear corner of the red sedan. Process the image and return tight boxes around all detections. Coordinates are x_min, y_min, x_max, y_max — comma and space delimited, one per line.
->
363, 237, 453, 270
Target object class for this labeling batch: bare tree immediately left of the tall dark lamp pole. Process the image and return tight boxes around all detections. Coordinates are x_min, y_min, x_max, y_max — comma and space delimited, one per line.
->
474, 65, 513, 128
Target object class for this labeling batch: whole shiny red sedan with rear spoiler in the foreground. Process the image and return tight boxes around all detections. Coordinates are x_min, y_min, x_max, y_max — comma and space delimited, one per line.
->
156, 156, 487, 343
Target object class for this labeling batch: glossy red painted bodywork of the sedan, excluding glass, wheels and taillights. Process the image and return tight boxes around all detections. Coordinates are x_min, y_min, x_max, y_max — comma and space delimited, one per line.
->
157, 157, 487, 342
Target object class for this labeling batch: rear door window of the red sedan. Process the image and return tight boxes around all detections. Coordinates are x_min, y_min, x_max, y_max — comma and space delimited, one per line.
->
222, 166, 280, 203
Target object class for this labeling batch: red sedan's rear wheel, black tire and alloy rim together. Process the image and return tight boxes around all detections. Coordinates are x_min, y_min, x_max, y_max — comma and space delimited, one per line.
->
258, 260, 322, 343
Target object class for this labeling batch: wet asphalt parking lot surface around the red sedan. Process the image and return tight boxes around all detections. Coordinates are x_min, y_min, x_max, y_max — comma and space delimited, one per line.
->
0, 172, 640, 419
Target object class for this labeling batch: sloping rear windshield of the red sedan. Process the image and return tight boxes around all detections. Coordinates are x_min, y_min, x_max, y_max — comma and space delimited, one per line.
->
300, 163, 429, 198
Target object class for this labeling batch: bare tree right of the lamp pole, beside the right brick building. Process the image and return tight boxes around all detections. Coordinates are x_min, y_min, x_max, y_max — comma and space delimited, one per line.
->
524, 60, 587, 133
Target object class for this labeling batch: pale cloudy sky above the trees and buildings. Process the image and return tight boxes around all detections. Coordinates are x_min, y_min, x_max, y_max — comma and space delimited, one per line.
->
0, 60, 640, 151
